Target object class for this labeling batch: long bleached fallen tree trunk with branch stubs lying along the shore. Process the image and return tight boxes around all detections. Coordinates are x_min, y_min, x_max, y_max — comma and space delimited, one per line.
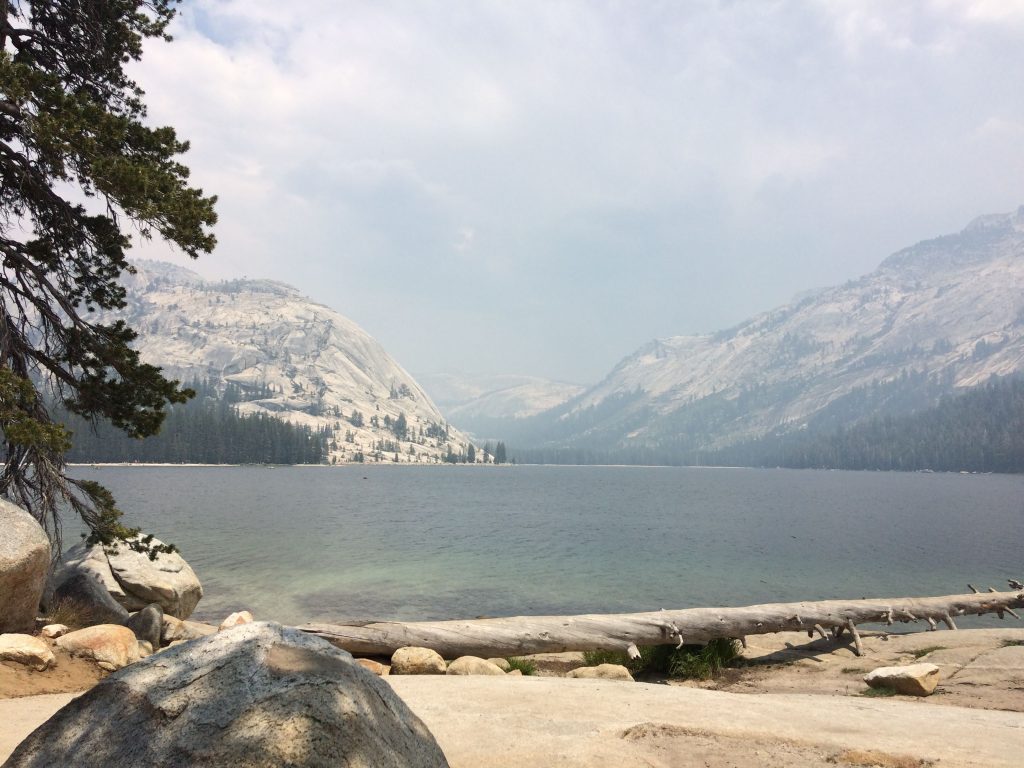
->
301, 582, 1024, 658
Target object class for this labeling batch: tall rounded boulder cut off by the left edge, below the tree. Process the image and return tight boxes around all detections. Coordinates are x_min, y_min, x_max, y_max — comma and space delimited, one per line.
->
0, 499, 50, 633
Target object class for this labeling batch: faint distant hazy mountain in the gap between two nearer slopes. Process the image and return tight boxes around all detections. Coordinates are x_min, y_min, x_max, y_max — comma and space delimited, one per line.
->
418, 374, 586, 438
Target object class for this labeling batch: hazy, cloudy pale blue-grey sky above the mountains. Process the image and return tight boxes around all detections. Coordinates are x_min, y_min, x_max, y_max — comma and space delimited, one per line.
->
131, 0, 1024, 384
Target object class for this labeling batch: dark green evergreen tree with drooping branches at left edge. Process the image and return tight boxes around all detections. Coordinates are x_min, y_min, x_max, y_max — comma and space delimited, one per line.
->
0, 0, 216, 545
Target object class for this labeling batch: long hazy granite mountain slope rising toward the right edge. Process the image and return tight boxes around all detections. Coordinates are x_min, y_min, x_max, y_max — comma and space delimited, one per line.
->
516, 207, 1024, 456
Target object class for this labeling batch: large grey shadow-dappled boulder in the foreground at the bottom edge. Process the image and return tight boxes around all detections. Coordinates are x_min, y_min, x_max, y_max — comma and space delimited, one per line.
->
4, 622, 447, 768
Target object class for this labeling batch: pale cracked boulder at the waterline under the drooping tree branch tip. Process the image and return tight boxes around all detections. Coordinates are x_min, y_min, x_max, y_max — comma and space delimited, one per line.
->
51, 539, 203, 618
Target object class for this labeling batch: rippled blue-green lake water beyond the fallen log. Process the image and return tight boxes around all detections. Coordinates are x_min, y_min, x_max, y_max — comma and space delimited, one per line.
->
68, 466, 1024, 626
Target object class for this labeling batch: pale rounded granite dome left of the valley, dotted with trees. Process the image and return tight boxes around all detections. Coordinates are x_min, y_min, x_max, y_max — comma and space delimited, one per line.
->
118, 261, 469, 462
